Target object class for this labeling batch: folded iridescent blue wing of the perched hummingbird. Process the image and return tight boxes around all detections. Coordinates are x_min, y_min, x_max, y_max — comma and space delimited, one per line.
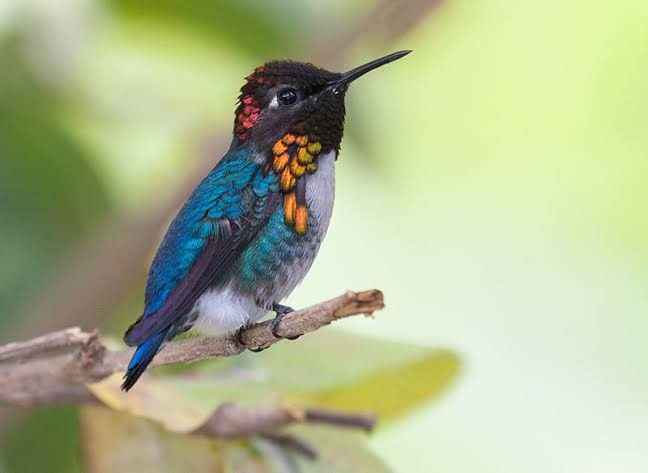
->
124, 152, 280, 346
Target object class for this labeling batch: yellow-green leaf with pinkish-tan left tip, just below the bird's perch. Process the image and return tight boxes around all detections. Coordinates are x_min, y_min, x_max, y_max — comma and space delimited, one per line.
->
89, 330, 459, 432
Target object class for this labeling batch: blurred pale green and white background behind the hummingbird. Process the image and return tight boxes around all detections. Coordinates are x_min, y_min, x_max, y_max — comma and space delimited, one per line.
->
0, 0, 648, 473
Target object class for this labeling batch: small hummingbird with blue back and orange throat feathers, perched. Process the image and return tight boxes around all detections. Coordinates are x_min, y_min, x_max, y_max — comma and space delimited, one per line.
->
122, 50, 411, 391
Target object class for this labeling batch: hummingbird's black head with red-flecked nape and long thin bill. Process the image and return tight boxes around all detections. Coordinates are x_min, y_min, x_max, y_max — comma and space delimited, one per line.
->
234, 51, 410, 156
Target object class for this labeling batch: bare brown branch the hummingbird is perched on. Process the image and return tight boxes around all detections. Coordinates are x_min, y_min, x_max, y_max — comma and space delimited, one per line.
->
0, 289, 384, 406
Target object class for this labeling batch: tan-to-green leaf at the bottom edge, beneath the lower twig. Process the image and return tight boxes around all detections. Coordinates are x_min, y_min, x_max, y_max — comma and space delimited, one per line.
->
81, 406, 390, 473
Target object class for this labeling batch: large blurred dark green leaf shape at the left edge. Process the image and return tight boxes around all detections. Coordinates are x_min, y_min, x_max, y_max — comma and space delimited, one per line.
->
0, 46, 108, 324
